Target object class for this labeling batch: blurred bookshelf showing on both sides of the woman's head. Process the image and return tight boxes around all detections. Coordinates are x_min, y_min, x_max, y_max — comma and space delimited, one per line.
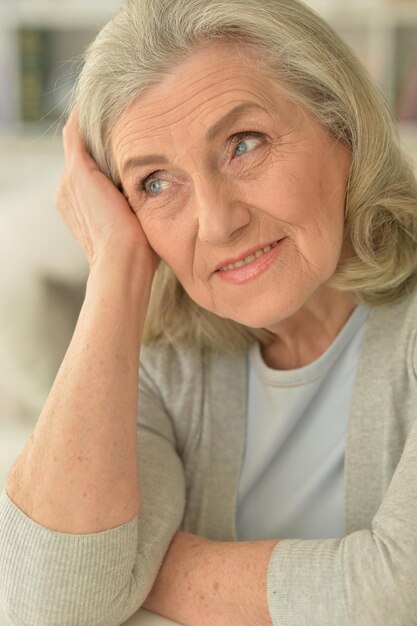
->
0, 0, 417, 143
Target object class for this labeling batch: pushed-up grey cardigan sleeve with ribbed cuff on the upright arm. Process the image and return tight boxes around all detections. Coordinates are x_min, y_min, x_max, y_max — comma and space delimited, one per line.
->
0, 356, 185, 626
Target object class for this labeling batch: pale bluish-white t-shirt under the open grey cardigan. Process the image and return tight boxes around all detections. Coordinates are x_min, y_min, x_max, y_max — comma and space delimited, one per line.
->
236, 305, 370, 541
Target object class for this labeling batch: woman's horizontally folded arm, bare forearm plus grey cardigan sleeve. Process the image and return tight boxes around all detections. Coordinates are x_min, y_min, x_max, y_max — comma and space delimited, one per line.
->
143, 410, 417, 626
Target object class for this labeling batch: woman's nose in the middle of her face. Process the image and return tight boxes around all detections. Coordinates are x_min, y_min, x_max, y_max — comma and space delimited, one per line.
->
194, 173, 251, 245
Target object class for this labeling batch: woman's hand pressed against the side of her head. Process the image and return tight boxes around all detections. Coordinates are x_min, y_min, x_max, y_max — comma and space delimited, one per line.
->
55, 109, 160, 270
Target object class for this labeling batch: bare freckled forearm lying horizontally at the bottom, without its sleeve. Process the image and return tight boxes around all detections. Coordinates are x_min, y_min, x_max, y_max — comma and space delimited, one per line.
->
142, 531, 279, 626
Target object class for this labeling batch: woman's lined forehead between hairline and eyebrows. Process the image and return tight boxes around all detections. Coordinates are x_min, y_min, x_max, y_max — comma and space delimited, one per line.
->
112, 61, 294, 158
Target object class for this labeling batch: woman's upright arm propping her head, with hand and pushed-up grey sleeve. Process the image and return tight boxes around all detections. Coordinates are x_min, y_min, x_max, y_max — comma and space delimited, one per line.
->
0, 109, 185, 626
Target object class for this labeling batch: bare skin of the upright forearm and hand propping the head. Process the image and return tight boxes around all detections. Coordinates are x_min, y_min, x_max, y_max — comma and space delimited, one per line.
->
5, 110, 159, 534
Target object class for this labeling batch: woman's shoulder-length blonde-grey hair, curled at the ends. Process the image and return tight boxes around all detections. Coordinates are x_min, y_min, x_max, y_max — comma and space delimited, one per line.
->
73, 0, 417, 352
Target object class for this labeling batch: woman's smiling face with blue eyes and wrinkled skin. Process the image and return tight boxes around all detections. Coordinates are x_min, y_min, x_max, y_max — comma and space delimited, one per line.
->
111, 43, 351, 330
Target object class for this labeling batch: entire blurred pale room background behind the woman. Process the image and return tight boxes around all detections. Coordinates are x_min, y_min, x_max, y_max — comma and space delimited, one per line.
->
0, 0, 417, 492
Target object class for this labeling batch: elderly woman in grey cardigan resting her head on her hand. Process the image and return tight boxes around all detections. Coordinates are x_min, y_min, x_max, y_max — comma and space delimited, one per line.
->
0, 0, 417, 626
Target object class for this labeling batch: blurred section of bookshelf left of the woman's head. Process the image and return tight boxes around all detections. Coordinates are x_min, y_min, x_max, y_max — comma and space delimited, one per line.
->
0, 0, 112, 139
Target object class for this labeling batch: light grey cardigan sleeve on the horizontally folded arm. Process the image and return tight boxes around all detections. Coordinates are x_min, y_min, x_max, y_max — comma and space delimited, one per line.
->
267, 412, 417, 626
